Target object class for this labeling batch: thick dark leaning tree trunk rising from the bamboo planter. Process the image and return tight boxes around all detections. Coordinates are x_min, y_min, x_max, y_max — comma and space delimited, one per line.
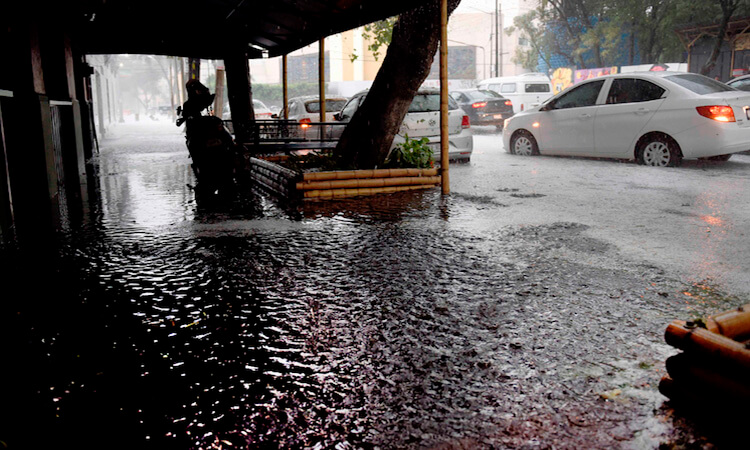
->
334, 0, 460, 169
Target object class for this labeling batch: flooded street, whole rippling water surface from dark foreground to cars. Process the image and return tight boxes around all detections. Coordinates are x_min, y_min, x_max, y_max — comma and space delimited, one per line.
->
2, 119, 750, 449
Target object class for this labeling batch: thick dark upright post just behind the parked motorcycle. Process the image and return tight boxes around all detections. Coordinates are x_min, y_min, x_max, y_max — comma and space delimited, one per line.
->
224, 47, 255, 143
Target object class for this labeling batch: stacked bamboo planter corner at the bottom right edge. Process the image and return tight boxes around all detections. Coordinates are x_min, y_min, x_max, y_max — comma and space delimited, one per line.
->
659, 304, 750, 407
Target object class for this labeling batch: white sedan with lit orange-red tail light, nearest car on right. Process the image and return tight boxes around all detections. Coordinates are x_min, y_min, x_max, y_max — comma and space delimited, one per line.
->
503, 72, 750, 166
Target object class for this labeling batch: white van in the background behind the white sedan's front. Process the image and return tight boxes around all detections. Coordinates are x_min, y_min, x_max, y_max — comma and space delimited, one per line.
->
477, 72, 552, 113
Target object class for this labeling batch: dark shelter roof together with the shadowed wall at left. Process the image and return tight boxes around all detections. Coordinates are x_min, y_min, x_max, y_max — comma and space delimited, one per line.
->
0, 0, 434, 246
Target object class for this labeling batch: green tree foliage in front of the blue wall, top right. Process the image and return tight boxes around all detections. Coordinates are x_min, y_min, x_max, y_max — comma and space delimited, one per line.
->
506, 0, 750, 70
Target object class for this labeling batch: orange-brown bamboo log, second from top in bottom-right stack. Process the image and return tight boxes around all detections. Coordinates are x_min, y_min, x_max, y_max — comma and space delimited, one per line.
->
664, 320, 750, 370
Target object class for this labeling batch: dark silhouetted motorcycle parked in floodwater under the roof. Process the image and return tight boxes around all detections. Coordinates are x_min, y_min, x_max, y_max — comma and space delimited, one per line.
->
177, 80, 236, 195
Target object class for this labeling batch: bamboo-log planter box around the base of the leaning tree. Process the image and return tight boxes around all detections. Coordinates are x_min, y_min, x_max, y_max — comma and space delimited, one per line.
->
250, 158, 441, 200
